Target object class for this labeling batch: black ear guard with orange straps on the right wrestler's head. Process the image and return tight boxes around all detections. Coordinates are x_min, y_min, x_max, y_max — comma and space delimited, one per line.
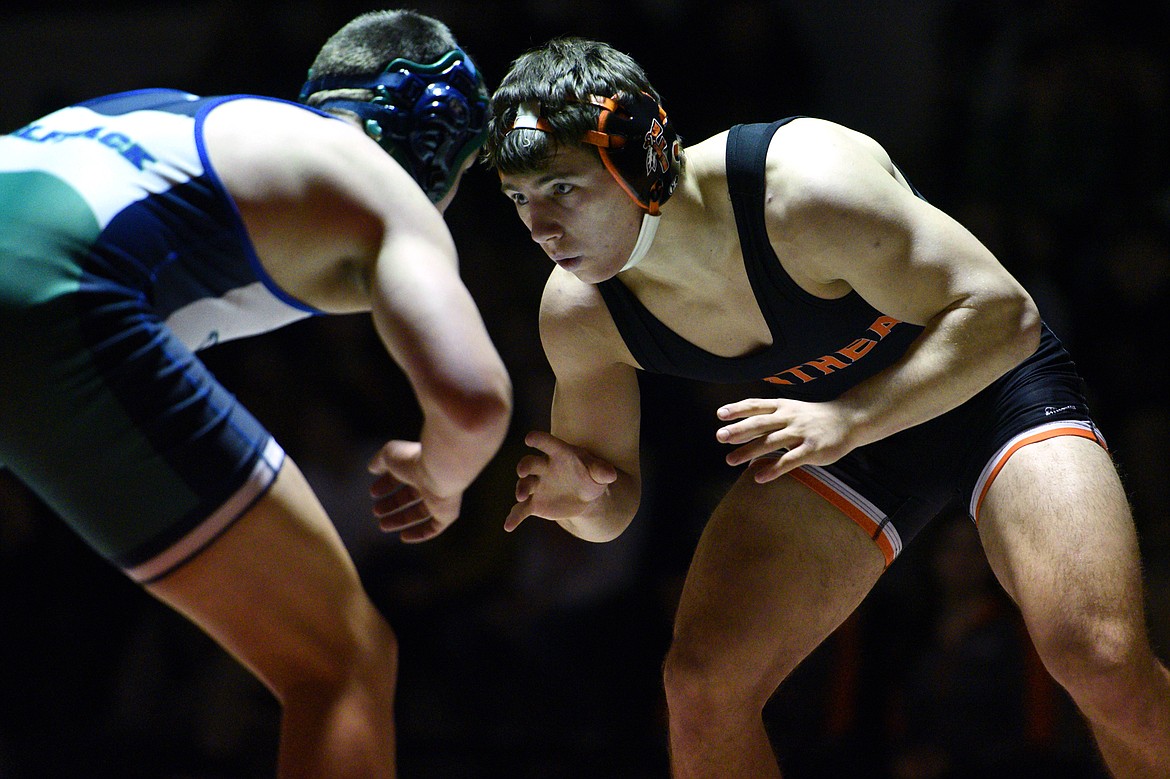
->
581, 92, 682, 216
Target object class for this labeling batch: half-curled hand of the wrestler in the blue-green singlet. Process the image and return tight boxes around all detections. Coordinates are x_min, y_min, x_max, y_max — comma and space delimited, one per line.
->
369, 441, 463, 543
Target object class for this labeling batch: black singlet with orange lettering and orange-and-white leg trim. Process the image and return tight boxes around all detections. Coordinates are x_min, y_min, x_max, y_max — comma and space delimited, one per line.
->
598, 117, 1103, 564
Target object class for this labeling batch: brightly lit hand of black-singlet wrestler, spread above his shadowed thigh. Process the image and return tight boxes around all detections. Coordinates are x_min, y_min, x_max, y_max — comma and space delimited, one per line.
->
715, 398, 853, 484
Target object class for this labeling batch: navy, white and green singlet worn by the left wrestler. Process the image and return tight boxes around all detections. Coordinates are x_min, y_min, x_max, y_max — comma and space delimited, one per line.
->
0, 89, 325, 581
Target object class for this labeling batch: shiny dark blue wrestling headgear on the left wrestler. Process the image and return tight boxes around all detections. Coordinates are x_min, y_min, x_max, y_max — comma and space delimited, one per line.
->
300, 48, 488, 202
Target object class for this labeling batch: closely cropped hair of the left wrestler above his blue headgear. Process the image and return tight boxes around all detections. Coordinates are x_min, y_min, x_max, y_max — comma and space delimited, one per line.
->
305, 11, 459, 105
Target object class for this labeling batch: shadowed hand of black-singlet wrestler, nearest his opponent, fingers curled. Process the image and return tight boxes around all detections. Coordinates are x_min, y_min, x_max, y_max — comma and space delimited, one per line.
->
504, 430, 618, 532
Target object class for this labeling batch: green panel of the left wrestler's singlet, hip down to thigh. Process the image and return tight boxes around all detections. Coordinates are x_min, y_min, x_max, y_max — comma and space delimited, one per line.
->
0, 172, 198, 559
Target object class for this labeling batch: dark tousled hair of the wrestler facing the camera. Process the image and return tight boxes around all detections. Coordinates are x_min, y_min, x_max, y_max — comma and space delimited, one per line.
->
483, 37, 661, 173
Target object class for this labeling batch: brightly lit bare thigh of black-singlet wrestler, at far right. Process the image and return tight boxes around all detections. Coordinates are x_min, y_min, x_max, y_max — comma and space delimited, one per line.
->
979, 436, 1143, 639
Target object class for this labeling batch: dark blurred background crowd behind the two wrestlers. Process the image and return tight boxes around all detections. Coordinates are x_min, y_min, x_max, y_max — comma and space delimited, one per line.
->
0, 0, 1170, 779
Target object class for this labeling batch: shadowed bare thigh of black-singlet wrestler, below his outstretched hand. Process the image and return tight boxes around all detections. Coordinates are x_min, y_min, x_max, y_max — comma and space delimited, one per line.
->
674, 474, 885, 695
